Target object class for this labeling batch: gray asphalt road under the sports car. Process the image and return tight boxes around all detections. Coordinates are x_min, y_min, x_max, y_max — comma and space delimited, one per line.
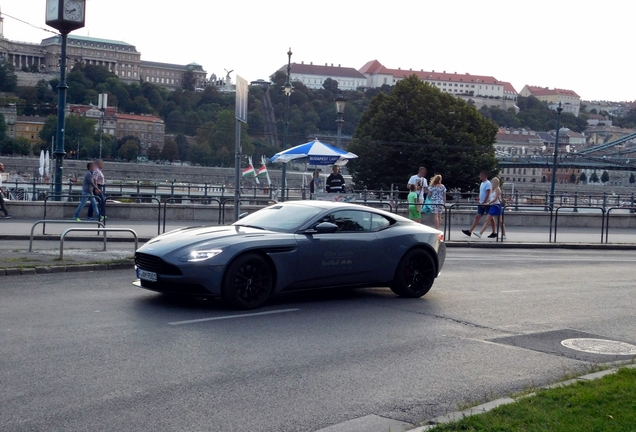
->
0, 248, 636, 432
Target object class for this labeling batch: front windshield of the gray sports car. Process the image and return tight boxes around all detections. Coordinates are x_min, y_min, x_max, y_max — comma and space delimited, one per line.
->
232, 205, 323, 232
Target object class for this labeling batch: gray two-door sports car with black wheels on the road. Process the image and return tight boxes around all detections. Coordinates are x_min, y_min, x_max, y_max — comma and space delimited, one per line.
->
135, 201, 446, 309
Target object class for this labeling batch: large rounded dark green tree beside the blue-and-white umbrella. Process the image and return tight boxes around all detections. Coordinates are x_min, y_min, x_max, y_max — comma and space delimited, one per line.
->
349, 75, 497, 190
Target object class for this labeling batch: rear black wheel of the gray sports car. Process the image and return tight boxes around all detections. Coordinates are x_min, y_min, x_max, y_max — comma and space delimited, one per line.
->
391, 249, 436, 298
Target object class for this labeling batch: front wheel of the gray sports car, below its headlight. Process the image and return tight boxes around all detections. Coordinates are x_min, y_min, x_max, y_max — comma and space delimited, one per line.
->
223, 253, 274, 309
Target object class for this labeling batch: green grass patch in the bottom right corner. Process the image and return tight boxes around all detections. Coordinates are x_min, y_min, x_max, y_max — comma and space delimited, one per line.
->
430, 368, 636, 432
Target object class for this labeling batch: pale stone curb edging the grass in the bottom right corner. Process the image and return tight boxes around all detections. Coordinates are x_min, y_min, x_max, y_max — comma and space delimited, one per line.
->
405, 364, 636, 432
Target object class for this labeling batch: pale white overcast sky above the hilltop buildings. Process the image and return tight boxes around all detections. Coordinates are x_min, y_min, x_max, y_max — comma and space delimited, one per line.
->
0, 0, 636, 101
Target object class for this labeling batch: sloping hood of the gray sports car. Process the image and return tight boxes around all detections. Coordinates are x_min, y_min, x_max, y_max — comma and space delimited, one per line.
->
138, 226, 281, 255
